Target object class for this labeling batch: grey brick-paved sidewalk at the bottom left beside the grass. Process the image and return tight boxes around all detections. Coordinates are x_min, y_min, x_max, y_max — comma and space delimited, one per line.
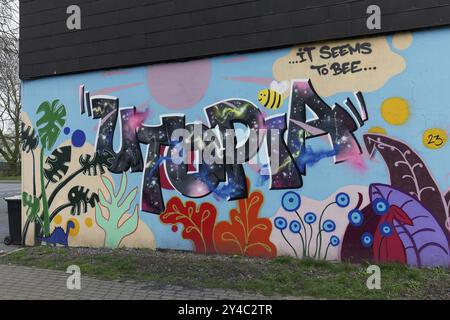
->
0, 264, 298, 300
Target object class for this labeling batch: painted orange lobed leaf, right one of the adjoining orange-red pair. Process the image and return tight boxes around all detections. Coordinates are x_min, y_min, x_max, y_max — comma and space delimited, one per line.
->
214, 181, 276, 257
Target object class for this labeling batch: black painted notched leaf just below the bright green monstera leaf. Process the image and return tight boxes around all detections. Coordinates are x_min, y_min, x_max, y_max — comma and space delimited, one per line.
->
44, 146, 72, 183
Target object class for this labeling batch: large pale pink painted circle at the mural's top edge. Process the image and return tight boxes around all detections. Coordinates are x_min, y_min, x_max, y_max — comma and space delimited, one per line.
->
147, 59, 211, 109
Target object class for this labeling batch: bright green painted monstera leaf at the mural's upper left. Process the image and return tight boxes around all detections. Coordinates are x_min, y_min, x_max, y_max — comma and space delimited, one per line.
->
36, 100, 67, 150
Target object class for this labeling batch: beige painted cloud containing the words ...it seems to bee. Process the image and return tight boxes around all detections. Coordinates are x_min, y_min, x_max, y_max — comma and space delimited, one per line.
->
273, 36, 406, 97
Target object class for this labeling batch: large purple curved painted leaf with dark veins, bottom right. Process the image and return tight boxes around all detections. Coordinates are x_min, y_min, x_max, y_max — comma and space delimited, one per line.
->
369, 184, 450, 267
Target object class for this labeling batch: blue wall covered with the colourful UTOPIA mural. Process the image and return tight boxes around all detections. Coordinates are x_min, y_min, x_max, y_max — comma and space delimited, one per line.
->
22, 28, 450, 267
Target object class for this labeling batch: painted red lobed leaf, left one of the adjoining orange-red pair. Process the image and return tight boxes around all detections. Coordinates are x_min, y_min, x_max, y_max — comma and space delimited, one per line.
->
159, 197, 217, 253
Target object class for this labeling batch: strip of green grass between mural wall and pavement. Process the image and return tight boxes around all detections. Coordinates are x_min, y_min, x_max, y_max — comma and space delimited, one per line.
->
0, 246, 450, 299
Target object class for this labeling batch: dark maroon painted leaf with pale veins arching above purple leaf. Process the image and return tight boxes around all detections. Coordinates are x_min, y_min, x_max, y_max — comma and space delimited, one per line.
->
364, 134, 447, 234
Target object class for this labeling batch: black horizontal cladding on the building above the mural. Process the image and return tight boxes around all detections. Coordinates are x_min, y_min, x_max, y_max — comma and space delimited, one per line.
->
20, 0, 450, 79
